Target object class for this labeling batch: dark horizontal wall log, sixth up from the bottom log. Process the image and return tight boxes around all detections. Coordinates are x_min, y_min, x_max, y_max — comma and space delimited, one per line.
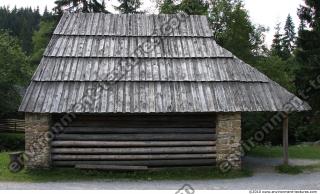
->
63, 127, 215, 134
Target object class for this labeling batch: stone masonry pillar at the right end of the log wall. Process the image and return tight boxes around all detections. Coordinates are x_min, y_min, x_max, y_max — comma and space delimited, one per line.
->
216, 113, 241, 171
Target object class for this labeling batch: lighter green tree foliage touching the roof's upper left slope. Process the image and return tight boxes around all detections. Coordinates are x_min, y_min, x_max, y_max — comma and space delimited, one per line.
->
31, 19, 56, 66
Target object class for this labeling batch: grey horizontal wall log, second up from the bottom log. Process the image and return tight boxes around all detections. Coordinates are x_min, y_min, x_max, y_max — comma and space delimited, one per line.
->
51, 154, 216, 160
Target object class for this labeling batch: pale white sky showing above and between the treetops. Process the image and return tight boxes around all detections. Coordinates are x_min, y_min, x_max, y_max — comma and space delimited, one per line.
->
0, 0, 303, 46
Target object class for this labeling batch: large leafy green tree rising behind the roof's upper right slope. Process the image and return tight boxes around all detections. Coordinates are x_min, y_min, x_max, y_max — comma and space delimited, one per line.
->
209, 0, 267, 63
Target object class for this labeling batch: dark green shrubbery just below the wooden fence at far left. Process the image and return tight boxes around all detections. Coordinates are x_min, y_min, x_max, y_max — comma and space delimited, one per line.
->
0, 133, 24, 152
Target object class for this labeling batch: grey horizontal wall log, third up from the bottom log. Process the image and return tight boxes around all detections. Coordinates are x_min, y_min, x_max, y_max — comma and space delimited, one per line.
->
52, 146, 216, 154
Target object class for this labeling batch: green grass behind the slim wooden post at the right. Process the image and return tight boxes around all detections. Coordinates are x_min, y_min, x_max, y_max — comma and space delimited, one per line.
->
247, 145, 320, 159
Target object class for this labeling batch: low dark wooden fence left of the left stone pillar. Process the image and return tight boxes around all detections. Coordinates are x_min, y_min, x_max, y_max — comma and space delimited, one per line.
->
0, 119, 25, 133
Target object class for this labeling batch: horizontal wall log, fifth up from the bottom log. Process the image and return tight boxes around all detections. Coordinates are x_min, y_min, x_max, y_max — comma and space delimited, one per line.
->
55, 134, 216, 141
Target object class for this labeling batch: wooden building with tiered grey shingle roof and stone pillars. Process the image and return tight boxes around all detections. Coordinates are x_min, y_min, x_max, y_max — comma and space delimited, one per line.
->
19, 13, 310, 169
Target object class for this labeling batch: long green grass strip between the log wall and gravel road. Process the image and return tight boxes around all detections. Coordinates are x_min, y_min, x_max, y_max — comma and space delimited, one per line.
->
0, 153, 252, 182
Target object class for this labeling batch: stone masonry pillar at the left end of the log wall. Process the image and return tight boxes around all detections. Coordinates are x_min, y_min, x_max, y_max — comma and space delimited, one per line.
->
25, 113, 51, 169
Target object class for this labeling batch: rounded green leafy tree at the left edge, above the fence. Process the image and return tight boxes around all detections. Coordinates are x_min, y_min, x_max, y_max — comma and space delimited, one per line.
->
0, 32, 32, 116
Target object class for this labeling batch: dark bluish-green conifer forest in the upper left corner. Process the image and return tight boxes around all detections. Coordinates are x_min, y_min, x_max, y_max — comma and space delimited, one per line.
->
0, 7, 40, 54
